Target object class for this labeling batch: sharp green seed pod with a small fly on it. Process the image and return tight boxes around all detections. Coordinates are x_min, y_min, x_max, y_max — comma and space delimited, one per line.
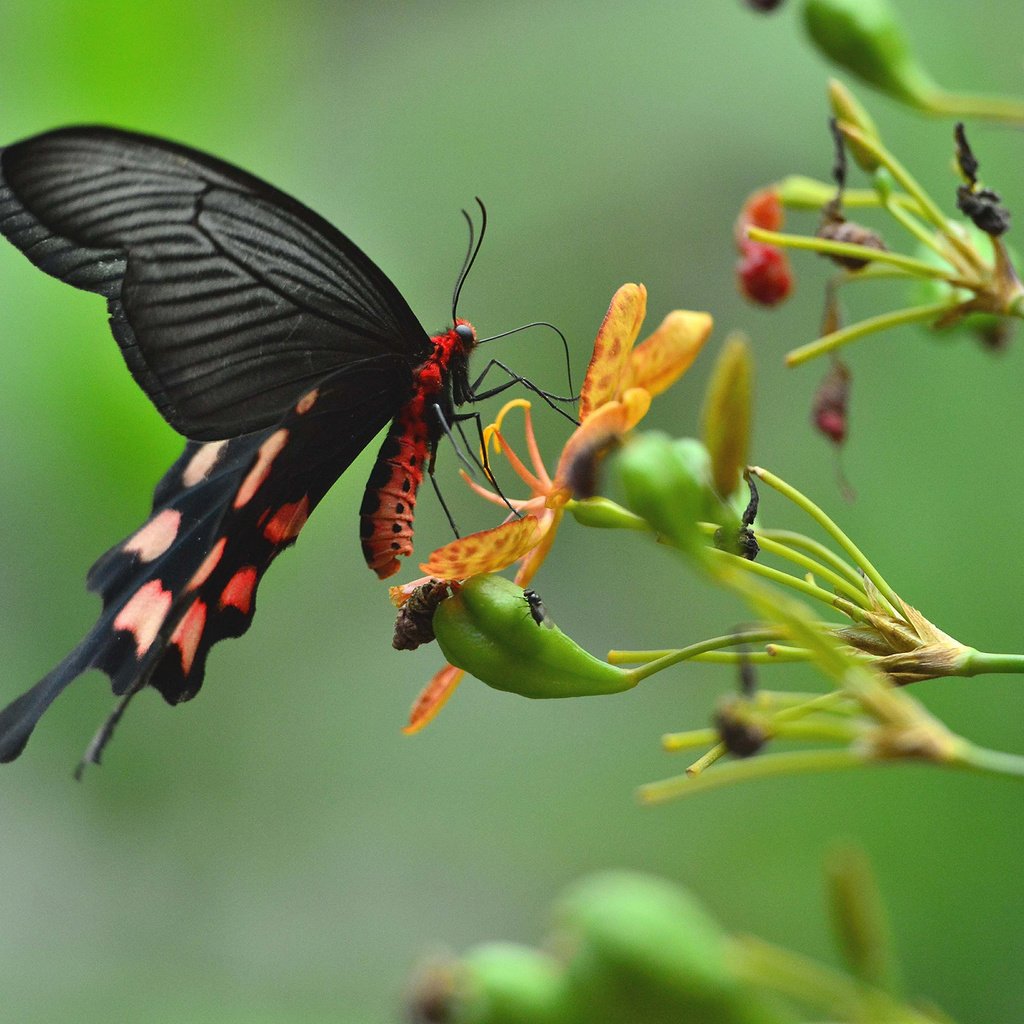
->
434, 575, 639, 697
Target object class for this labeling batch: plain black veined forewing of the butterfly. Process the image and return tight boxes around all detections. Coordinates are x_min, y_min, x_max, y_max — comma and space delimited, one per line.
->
0, 127, 431, 440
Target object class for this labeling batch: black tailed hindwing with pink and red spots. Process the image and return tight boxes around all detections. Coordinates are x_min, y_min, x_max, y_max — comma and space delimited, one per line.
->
0, 356, 412, 761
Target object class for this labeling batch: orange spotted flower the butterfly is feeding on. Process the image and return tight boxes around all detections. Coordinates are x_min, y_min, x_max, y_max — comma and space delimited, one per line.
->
401, 285, 712, 732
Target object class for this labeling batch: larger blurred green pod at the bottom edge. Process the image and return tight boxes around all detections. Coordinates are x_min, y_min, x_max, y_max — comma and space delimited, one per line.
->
556, 871, 792, 1024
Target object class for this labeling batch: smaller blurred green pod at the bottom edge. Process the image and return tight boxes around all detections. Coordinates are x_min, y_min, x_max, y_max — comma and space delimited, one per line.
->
458, 942, 571, 1024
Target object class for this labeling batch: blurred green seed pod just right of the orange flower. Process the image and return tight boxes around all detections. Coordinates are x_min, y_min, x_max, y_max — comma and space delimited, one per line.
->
616, 432, 721, 554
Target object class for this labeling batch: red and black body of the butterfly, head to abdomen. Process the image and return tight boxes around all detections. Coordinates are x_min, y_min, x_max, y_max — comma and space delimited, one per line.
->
359, 319, 476, 580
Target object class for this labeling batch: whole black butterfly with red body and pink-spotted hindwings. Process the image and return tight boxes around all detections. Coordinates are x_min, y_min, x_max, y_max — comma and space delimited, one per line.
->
0, 126, 503, 763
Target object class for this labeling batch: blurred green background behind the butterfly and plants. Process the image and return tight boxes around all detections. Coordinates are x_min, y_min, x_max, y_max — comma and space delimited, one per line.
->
0, 0, 1024, 1024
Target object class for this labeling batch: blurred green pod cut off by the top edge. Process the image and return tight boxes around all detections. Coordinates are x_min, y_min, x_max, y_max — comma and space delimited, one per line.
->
804, 0, 939, 110
